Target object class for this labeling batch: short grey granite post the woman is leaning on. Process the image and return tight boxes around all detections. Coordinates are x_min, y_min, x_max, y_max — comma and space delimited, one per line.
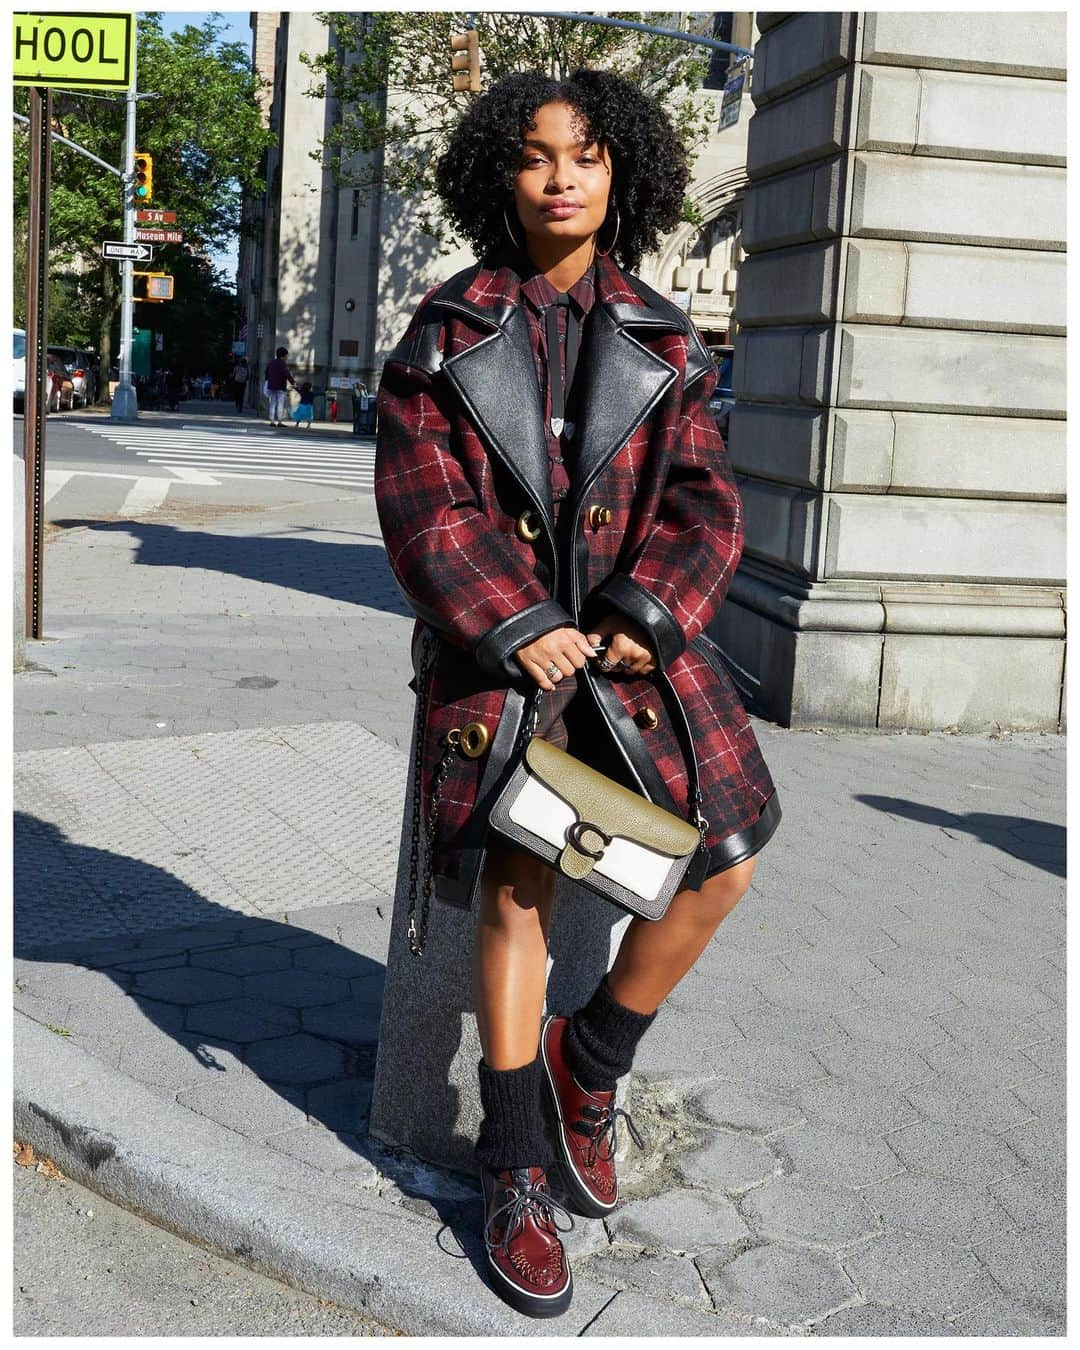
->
369, 702, 629, 1172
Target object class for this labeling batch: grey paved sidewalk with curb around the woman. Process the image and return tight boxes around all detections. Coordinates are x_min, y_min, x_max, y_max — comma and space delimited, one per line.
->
15, 501, 1065, 1335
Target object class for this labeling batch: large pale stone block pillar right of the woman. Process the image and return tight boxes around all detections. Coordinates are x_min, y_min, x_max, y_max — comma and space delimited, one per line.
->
716, 11, 1065, 732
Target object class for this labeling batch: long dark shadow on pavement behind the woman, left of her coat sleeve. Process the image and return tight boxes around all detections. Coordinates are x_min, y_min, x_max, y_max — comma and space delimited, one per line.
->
46, 520, 413, 618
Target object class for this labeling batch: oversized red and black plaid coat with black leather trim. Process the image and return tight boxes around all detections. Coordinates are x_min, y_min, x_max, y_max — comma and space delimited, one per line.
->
375, 254, 780, 905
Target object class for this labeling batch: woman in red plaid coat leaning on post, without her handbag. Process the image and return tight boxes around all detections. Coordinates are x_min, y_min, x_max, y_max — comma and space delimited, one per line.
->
375, 70, 780, 1316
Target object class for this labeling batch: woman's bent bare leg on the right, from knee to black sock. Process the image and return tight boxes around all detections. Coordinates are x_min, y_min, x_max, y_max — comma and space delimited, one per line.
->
608, 855, 757, 1013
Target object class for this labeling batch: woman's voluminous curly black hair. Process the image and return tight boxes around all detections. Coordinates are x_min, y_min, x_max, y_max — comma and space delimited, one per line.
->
435, 68, 690, 271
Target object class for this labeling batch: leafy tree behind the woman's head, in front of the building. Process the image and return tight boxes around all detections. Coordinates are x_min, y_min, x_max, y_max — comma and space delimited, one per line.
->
301, 11, 711, 252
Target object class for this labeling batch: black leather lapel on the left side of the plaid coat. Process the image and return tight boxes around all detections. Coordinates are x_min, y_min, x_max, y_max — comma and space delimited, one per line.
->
440, 301, 555, 531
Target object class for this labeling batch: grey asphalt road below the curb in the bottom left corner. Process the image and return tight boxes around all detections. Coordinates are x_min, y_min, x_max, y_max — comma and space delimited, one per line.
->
12, 1162, 397, 1337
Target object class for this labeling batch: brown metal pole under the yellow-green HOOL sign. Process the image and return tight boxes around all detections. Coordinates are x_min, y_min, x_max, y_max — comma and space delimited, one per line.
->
23, 85, 53, 637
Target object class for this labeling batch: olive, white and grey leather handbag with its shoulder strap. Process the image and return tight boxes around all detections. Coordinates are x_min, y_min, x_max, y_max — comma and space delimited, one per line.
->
489, 675, 709, 919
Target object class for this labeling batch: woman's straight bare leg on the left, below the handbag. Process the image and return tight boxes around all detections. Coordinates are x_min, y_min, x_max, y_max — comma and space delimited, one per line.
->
473, 849, 555, 1069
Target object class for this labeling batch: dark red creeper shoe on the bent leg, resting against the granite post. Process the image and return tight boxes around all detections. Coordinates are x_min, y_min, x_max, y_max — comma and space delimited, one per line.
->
540, 1017, 644, 1219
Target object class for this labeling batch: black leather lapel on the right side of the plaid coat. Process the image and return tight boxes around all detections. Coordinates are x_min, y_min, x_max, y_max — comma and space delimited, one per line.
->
563, 301, 678, 512
